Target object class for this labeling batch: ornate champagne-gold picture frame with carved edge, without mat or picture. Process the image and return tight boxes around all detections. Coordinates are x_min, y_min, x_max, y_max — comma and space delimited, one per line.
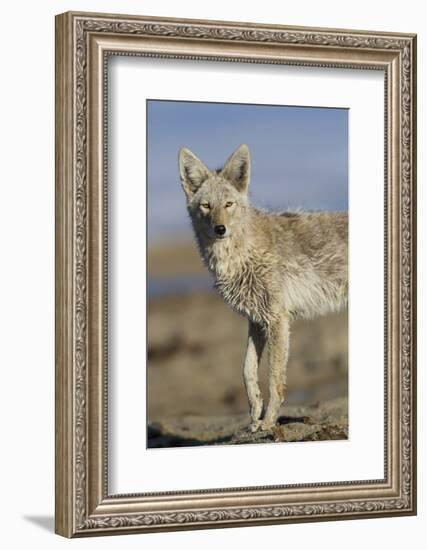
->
55, 12, 416, 537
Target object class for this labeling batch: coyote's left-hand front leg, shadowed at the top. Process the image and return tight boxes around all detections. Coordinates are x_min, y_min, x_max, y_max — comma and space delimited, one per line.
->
243, 321, 265, 431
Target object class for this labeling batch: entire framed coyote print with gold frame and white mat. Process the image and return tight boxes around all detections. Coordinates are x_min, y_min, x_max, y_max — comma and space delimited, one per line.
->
56, 12, 416, 537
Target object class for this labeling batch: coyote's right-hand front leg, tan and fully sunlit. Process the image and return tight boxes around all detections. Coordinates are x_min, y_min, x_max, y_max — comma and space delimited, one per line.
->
260, 315, 289, 430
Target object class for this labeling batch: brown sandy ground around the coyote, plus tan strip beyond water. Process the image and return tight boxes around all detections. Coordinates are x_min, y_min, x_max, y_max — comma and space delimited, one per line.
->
147, 243, 348, 447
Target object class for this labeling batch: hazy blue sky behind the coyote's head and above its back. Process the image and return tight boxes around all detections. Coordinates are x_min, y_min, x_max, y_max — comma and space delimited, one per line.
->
147, 100, 348, 240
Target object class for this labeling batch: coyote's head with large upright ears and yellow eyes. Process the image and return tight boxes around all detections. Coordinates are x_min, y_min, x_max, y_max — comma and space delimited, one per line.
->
179, 145, 250, 239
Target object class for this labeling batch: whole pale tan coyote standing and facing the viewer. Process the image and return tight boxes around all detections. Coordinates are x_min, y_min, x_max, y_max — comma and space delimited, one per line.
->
179, 145, 348, 432
